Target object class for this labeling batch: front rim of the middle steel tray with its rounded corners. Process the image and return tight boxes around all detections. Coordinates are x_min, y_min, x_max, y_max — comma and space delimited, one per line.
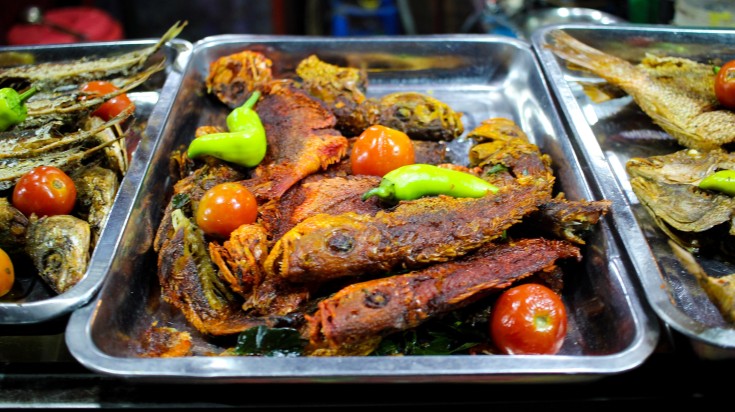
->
65, 305, 657, 382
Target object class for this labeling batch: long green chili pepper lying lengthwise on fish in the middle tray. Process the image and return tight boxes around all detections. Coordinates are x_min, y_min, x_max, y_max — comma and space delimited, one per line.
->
362, 164, 498, 202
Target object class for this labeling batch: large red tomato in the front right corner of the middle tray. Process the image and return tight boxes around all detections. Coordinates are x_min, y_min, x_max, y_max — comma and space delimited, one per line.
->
490, 283, 567, 355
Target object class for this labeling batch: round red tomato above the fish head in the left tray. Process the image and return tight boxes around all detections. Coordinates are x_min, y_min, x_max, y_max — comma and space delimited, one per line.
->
13, 166, 77, 217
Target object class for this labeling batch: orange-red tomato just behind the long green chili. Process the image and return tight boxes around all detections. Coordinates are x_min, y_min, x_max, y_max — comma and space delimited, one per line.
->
350, 125, 416, 177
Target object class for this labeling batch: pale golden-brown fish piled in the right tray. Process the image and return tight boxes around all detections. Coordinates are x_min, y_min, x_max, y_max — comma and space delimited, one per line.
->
548, 30, 735, 323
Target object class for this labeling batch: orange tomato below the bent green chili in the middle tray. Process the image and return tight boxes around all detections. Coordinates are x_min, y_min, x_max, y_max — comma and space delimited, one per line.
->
195, 183, 258, 238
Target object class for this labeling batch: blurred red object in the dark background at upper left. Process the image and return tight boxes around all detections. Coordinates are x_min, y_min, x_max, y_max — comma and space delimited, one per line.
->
8, 7, 124, 46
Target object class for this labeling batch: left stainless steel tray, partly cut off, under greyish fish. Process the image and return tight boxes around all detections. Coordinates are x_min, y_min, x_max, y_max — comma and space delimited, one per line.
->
0, 39, 193, 325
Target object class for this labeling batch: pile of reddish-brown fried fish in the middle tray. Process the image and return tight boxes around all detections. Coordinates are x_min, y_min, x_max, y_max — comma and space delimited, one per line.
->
142, 50, 610, 357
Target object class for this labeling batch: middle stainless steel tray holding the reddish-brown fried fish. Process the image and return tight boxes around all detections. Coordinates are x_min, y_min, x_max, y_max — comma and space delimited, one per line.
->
66, 35, 659, 382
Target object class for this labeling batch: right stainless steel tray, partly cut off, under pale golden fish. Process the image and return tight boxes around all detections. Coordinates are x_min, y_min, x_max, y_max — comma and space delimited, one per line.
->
532, 24, 735, 358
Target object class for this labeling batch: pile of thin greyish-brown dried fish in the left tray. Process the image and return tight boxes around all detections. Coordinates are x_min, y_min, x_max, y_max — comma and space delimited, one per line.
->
0, 23, 185, 293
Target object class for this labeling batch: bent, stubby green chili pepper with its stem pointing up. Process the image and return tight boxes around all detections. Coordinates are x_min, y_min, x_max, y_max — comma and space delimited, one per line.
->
188, 90, 267, 167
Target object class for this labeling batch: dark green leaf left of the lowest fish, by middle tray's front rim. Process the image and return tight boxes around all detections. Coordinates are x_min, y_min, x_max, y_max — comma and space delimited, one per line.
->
235, 326, 306, 356
